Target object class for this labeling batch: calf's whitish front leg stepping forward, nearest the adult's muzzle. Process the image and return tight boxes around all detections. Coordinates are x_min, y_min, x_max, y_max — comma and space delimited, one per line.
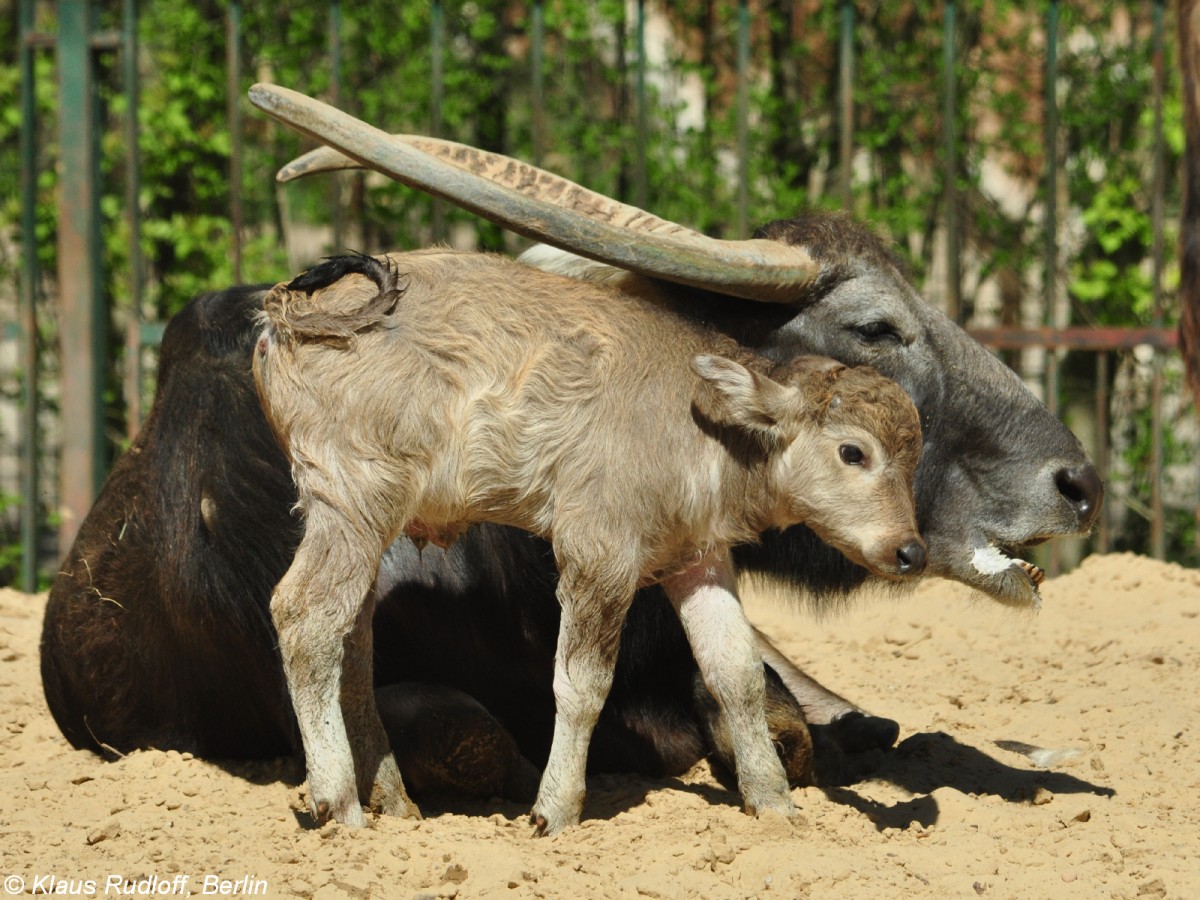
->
664, 552, 796, 817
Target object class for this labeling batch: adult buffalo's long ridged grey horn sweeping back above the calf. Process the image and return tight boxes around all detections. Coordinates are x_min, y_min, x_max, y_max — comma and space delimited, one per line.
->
250, 84, 821, 302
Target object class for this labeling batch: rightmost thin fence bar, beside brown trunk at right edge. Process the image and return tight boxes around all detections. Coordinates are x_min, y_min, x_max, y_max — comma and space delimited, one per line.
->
1150, 0, 1166, 559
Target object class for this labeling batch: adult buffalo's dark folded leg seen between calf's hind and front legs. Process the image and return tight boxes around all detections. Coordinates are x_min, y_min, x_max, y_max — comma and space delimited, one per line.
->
376, 683, 540, 811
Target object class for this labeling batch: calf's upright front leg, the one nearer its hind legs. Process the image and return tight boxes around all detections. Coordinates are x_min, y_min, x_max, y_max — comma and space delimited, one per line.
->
530, 566, 635, 835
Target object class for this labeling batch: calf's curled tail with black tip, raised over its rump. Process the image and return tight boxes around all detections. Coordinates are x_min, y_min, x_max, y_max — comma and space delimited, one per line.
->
263, 253, 408, 346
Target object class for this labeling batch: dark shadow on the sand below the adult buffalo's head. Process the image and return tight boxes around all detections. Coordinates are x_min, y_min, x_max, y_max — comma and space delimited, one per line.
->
823, 731, 1116, 832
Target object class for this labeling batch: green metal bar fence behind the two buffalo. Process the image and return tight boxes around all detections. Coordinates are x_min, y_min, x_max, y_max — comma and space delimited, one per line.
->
19, 0, 1176, 589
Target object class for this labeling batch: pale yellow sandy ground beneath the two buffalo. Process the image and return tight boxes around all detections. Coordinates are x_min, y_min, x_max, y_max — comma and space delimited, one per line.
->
0, 556, 1200, 899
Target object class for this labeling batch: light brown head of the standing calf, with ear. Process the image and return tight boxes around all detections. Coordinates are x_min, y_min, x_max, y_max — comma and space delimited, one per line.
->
692, 355, 925, 578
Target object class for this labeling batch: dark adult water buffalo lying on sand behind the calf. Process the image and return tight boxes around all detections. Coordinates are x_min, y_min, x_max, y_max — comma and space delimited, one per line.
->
42, 90, 1102, 796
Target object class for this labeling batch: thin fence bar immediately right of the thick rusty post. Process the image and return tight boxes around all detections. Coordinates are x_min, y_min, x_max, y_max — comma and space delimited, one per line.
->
121, 0, 143, 440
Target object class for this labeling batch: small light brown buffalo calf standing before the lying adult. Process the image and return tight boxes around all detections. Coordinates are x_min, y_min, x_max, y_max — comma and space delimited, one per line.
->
254, 250, 925, 833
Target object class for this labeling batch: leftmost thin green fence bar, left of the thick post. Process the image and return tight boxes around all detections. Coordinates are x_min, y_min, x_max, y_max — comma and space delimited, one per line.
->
18, 0, 41, 593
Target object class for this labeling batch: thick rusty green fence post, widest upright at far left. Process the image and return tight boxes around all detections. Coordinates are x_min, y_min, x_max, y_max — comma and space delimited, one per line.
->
56, 0, 108, 551
